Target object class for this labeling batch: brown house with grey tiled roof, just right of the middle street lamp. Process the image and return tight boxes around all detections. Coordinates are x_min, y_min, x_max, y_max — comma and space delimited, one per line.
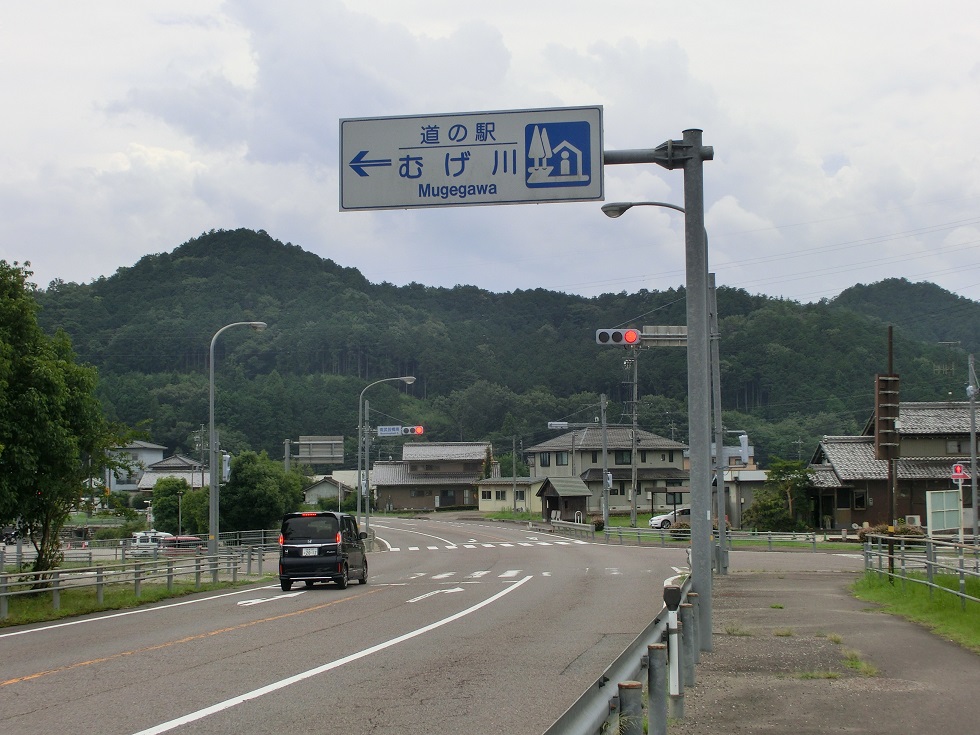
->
371, 442, 500, 510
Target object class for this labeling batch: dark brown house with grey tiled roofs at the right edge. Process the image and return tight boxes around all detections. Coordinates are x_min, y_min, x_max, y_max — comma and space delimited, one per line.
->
809, 401, 973, 530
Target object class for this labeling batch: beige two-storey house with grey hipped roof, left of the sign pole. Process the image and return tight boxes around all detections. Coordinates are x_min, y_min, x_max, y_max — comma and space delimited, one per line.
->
527, 425, 690, 513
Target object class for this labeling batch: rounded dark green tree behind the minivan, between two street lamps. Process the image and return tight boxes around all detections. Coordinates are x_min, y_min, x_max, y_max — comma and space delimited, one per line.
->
220, 452, 303, 531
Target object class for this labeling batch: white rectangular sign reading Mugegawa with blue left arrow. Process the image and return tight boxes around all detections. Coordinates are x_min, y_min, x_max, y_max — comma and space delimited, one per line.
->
340, 106, 603, 211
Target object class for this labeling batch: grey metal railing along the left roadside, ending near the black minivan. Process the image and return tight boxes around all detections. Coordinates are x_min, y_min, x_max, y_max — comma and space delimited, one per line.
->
0, 546, 278, 620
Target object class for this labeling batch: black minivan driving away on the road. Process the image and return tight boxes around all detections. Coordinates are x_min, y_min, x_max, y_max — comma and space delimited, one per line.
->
279, 511, 367, 592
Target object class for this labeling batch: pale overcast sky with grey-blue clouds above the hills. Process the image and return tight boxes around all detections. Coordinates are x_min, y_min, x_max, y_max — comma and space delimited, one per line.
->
0, 0, 980, 302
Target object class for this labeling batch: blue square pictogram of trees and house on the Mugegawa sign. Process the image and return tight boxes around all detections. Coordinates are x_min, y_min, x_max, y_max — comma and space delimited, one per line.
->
524, 120, 592, 189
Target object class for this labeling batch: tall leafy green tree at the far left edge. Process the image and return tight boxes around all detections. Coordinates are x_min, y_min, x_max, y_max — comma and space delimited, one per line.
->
0, 260, 125, 572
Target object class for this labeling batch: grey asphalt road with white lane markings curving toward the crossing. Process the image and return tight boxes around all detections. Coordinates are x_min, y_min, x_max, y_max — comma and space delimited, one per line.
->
0, 517, 686, 735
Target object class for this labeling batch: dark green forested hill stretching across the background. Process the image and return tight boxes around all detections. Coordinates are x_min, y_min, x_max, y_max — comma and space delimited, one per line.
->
30, 229, 980, 466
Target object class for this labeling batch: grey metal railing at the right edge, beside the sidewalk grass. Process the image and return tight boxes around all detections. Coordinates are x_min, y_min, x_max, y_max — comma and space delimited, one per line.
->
864, 535, 980, 610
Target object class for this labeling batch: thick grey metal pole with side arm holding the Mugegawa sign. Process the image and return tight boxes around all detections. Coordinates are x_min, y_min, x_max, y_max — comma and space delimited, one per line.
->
603, 130, 714, 651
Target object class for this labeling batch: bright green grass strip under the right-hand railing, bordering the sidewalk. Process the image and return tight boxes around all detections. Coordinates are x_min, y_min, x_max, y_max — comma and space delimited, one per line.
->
852, 572, 980, 653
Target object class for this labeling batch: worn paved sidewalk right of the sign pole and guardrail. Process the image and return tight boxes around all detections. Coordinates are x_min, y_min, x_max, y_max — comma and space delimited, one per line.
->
669, 571, 980, 735
